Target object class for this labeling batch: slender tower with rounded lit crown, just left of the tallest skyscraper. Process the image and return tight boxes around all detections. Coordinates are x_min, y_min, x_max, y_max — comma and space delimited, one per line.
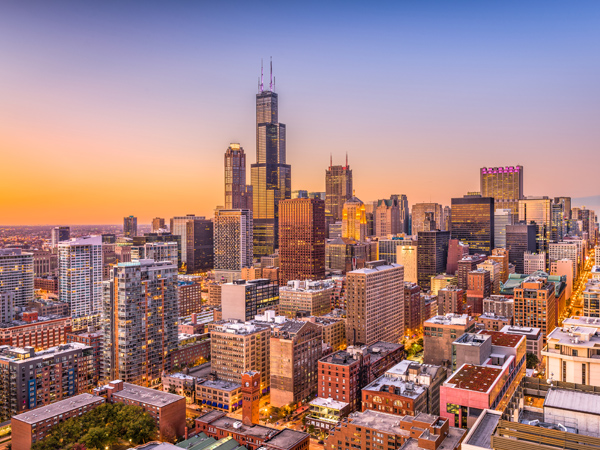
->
225, 144, 252, 210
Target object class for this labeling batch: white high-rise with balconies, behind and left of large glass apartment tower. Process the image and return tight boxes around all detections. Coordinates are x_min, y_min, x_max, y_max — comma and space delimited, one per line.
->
58, 236, 102, 331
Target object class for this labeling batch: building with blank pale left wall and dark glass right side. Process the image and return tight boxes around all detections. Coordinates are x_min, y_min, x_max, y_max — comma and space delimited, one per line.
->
221, 278, 279, 322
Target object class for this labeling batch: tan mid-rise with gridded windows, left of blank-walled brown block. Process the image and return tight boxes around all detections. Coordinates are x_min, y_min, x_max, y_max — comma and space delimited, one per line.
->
210, 322, 271, 394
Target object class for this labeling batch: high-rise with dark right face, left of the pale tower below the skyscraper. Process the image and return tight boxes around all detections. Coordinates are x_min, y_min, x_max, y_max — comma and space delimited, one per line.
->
171, 214, 214, 272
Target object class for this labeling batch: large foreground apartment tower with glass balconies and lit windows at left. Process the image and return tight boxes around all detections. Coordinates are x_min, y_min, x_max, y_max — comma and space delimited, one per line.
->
102, 259, 179, 386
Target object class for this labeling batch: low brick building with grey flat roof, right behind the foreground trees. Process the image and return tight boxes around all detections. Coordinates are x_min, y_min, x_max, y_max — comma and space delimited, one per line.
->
94, 380, 185, 440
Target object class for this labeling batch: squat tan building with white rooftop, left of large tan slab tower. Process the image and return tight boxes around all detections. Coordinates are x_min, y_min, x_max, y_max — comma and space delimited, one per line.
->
279, 280, 335, 319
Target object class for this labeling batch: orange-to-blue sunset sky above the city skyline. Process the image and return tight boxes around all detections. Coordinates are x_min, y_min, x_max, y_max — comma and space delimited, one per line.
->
0, 0, 600, 225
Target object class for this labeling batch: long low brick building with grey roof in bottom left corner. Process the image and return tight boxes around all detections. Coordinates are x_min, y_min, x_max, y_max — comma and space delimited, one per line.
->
10, 393, 105, 450
